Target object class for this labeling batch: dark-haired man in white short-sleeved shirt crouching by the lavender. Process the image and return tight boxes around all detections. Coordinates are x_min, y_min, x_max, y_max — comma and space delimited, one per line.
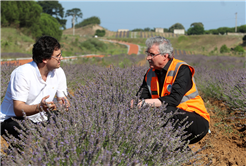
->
0, 36, 69, 138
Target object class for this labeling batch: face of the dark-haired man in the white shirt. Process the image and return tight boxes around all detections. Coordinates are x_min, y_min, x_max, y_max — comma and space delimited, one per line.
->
48, 49, 63, 70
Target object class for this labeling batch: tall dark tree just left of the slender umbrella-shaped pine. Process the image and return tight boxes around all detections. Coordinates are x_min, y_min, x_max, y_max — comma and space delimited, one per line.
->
37, 0, 67, 29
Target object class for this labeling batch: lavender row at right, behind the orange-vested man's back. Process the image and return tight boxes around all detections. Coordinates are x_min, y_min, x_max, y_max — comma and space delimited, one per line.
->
177, 55, 246, 115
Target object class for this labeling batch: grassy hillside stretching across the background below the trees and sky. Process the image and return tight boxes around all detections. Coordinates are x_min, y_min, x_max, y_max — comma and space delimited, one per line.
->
0, 25, 246, 58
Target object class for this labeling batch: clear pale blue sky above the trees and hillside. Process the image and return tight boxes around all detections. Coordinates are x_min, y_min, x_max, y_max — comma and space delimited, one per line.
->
58, 0, 246, 31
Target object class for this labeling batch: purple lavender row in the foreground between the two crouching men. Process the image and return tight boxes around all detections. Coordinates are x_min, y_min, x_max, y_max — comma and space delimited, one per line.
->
3, 64, 197, 165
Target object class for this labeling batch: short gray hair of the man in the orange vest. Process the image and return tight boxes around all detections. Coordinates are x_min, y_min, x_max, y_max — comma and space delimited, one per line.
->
145, 36, 173, 58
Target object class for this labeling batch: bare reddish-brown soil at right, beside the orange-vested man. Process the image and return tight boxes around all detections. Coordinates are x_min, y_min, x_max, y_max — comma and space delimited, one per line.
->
189, 100, 246, 166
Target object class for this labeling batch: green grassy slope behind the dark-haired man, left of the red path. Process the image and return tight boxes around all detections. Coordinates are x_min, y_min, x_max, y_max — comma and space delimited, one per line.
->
0, 28, 127, 59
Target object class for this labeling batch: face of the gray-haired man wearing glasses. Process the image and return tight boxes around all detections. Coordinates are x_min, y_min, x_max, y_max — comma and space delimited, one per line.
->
146, 45, 168, 70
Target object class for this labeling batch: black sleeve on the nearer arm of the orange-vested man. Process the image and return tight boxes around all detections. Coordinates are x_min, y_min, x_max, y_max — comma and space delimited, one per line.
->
159, 65, 192, 107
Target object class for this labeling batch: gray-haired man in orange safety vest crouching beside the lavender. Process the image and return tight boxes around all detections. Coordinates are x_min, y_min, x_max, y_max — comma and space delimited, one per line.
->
135, 37, 210, 144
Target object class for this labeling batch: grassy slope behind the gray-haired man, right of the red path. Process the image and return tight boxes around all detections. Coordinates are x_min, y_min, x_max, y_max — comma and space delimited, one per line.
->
110, 35, 243, 56
